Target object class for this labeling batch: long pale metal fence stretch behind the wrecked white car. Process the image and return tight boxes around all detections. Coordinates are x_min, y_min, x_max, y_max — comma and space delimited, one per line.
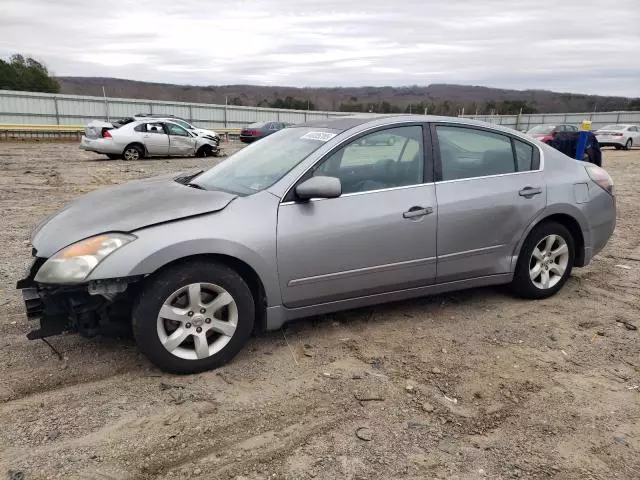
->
0, 90, 345, 128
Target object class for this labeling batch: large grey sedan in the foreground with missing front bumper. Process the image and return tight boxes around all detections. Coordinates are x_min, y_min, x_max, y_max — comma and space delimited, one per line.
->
17, 116, 616, 373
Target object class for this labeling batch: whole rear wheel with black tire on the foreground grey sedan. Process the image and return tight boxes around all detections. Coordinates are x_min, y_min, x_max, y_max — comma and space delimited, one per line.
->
511, 222, 575, 299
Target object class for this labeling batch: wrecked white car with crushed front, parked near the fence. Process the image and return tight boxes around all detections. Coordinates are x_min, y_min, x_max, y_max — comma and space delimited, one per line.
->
80, 119, 220, 160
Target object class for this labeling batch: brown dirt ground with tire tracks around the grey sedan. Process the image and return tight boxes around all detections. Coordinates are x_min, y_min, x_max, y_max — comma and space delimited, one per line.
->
0, 143, 640, 480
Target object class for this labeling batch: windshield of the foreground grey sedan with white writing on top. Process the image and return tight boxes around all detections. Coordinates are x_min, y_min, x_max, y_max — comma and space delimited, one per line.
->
191, 128, 338, 195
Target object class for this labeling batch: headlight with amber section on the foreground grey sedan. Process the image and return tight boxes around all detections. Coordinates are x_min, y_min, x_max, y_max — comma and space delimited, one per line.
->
35, 233, 136, 283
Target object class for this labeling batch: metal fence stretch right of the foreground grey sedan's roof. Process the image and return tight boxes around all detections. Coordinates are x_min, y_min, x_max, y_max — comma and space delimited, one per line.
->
463, 111, 640, 131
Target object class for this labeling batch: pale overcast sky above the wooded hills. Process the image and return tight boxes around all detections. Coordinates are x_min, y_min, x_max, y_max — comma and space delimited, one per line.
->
0, 0, 640, 97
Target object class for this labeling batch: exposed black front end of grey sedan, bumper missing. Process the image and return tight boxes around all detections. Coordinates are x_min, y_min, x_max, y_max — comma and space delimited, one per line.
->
16, 251, 141, 340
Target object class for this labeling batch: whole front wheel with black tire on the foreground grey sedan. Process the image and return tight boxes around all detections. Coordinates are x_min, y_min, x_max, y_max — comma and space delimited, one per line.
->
132, 261, 255, 374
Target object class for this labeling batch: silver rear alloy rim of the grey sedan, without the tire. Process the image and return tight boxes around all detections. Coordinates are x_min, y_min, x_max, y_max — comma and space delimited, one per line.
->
529, 235, 569, 290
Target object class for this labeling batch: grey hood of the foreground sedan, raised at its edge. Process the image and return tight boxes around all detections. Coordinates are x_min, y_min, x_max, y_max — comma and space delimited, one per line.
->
31, 174, 236, 257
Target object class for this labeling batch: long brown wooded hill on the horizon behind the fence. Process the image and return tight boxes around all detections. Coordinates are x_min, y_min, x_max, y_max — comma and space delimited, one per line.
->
57, 77, 640, 114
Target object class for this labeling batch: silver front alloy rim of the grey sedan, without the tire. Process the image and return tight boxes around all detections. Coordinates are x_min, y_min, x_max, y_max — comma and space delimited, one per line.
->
157, 283, 238, 360
